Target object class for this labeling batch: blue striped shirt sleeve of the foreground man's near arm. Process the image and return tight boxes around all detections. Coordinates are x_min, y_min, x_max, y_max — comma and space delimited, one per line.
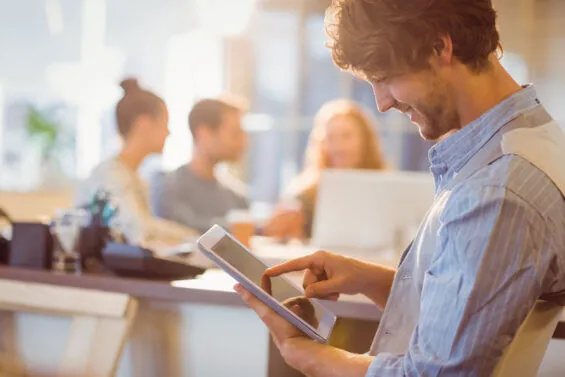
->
367, 187, 550, 377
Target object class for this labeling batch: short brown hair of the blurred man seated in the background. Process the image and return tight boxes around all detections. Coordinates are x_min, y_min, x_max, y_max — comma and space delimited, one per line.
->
188, 98, 242, 138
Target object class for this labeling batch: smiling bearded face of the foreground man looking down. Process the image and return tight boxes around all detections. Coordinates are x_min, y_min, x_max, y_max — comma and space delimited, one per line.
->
371, 62, 461, 140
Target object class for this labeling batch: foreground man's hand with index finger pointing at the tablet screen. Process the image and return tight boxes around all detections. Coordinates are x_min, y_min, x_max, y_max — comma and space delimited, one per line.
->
265, 251, 395, 308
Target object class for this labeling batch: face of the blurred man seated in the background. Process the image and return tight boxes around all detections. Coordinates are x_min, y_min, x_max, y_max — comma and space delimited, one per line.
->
207, 111, 242, 162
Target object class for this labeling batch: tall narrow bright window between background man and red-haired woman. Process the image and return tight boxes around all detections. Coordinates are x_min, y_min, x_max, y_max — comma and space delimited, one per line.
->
247, 11, 299, 202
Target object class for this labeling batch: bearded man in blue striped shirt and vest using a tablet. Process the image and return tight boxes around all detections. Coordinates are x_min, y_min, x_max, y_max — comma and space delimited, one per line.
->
235, 0, 565, 377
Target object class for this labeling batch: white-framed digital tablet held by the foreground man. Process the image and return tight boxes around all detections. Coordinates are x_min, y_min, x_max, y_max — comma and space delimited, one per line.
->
197, 225, 336, 343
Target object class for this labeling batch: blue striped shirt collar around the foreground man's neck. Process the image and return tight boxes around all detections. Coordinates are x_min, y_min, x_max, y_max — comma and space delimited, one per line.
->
428, 85, 540, 188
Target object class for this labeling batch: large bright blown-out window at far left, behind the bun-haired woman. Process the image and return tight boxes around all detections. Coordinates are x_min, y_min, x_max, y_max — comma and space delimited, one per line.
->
0, 0, 203, 190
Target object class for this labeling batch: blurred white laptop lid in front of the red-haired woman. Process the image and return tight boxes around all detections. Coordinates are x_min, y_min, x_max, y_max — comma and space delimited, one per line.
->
311, 169, 435, 251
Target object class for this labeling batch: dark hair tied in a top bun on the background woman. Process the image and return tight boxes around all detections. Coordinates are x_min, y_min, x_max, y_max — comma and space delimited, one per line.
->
116, 79, 165, 136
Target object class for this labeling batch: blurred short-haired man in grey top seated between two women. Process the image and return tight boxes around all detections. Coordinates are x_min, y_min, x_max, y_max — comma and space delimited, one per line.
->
152, 99, 247, 232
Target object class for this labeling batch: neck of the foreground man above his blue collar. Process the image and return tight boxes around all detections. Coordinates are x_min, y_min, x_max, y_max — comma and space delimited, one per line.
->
457, 59, 521, 127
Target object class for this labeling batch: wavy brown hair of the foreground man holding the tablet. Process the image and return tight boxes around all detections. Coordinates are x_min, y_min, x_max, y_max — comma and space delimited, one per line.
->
326, 0, 502, 78
